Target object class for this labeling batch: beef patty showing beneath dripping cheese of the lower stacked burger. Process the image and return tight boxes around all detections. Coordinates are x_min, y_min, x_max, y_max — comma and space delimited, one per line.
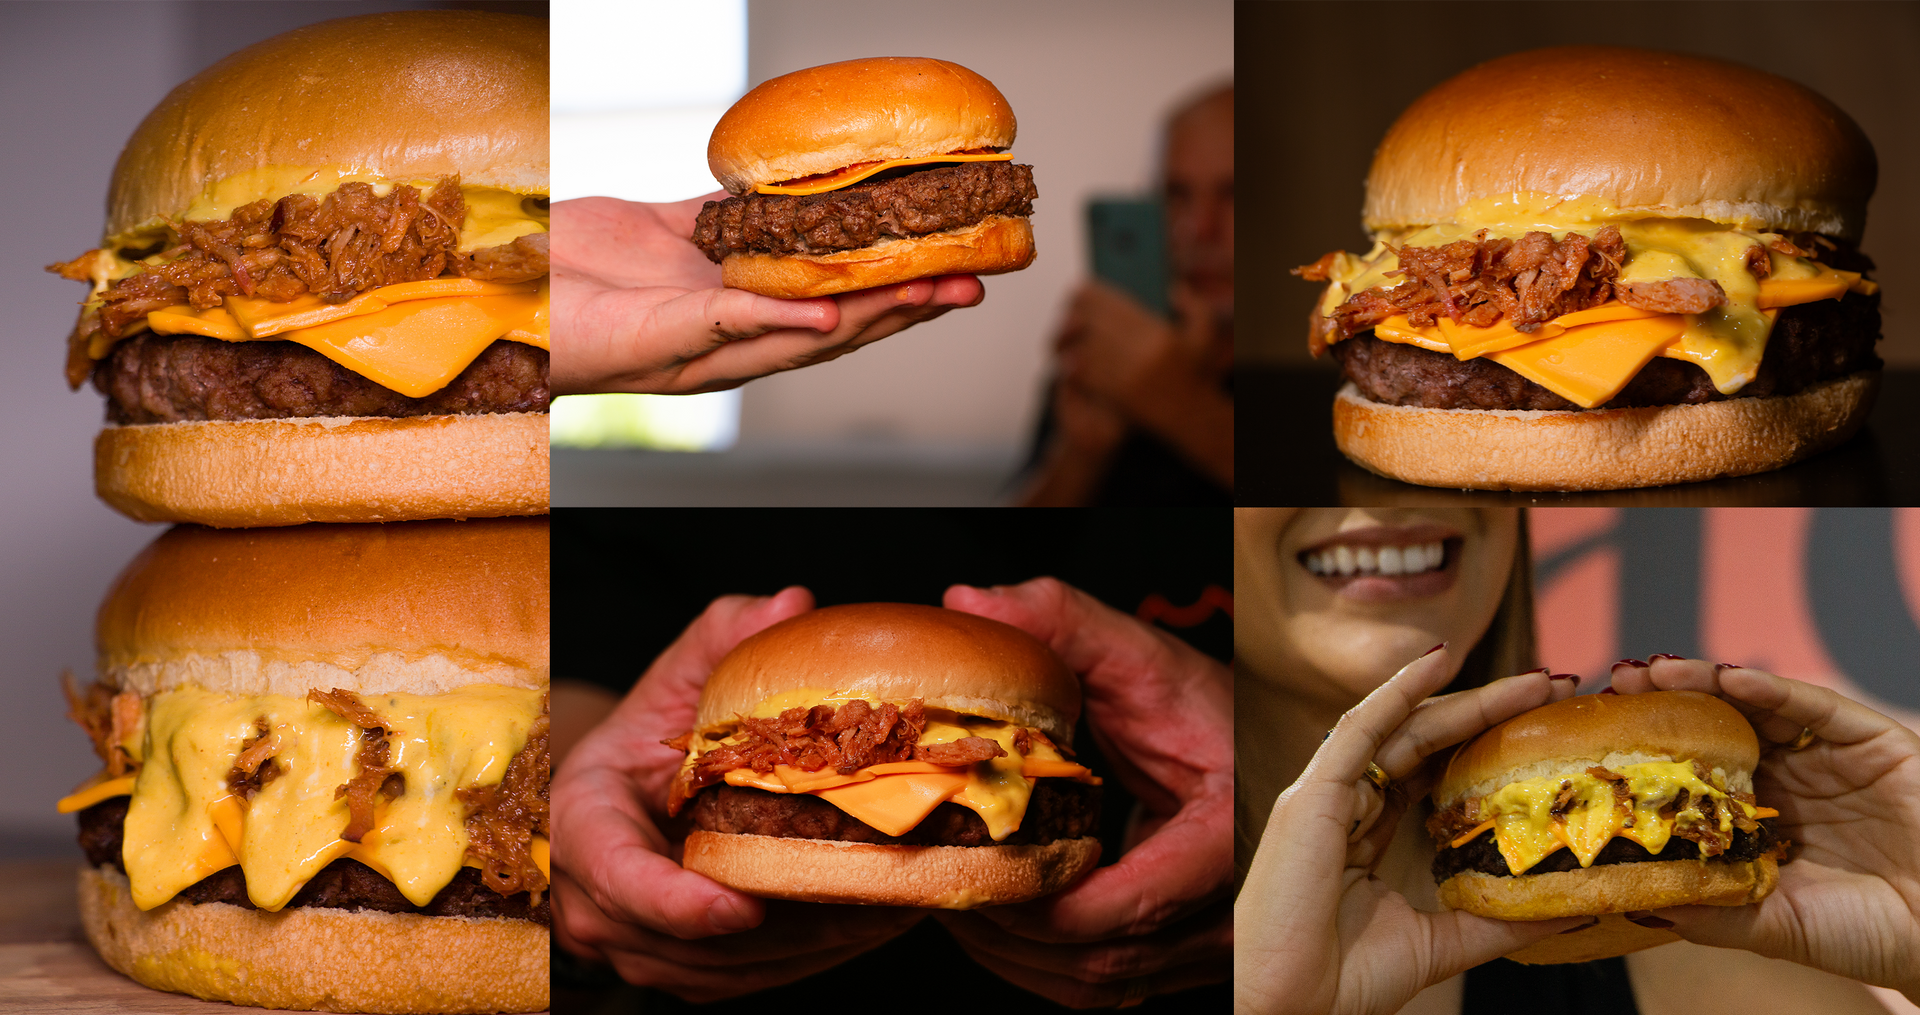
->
79, 796, 553, 927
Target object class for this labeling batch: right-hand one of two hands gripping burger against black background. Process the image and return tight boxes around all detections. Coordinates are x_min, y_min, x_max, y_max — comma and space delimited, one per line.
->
941, 578, 1233, 1007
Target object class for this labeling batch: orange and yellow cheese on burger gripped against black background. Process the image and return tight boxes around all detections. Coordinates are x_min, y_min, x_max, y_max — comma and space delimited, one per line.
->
687, 689, 1098, 842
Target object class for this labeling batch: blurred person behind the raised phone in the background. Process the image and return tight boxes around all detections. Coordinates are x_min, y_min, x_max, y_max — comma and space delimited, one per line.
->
1020, 83, 1233, 507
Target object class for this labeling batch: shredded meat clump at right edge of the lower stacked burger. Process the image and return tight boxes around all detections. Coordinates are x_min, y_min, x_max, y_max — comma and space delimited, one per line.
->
455, 696, 553, 904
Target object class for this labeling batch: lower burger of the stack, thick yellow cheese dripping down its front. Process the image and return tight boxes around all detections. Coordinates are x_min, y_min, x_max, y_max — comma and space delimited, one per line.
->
60, 518, 551, 1013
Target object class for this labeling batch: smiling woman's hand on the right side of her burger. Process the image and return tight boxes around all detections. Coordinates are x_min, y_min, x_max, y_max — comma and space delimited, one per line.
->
1613, 656, 1920, 1003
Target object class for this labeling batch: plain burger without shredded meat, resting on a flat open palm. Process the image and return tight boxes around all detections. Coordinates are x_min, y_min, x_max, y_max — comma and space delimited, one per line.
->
693, 58, 1039, 299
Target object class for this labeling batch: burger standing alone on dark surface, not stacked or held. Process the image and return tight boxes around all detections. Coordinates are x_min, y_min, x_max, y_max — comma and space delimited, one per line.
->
1296, 46, 1880, 489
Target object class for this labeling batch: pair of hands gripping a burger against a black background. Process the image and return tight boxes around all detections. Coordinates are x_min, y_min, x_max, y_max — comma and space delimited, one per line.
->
553, 578, 1233, 1007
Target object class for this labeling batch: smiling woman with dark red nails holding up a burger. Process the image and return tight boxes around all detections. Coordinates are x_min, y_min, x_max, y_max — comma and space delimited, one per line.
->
1235, 508, 1920, 1015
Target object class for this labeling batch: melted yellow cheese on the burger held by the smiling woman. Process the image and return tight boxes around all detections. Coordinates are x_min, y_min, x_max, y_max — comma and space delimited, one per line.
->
1452, 762, 1778, 873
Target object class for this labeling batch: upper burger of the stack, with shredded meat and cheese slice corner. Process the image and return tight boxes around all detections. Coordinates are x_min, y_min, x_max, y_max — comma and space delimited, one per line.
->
50, 12, 549, 526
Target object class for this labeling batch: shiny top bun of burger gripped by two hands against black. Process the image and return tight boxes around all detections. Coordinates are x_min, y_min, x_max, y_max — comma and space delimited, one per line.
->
695, 602, 1081, 743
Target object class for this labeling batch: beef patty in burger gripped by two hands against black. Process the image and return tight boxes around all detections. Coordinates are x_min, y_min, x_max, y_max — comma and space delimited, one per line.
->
693, 779, 1100, 846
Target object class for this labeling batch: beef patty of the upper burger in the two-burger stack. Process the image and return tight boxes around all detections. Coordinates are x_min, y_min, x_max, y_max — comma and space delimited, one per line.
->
94, 334, 551, 424
